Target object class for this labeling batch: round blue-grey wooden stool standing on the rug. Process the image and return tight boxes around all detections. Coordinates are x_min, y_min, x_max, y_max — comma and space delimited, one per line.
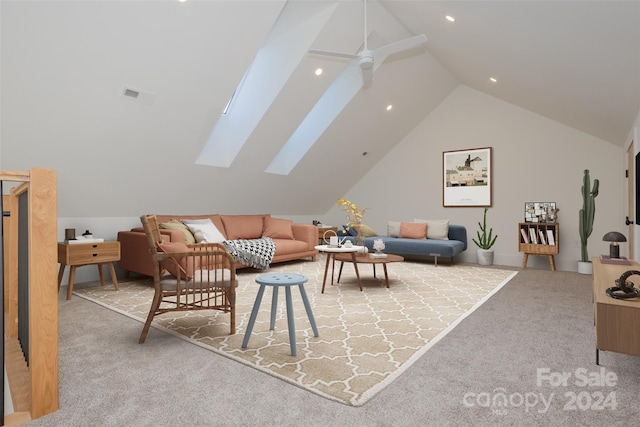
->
242, 273, 319, 356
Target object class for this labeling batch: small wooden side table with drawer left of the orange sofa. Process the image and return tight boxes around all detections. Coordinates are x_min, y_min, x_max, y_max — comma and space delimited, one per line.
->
58, 242, 120, 299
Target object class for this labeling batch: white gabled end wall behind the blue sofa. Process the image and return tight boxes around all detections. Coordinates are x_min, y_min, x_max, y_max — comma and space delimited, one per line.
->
320, 86, 628, 271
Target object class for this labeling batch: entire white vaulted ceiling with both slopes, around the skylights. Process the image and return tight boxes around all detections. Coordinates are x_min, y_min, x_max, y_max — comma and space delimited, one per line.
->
0, 0, 640, 216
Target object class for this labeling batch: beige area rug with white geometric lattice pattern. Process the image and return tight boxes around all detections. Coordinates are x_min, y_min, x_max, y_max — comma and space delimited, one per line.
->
74, 256, 517, 406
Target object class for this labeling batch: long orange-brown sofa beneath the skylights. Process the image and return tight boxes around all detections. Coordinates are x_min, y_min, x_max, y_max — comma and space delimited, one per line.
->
118, 214, 318, 277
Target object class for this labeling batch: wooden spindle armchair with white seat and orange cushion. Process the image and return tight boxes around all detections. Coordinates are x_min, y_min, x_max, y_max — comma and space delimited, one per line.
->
140, 215, 237, 343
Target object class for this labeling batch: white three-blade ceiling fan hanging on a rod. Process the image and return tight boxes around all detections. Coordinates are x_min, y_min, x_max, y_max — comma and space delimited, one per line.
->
309, 0, 427, 88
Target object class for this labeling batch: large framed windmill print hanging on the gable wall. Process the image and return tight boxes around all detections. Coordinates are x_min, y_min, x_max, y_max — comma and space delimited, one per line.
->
442, 147, 493, 208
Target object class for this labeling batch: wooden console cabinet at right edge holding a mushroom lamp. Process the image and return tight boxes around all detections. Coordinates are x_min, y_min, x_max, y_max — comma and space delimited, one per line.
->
593, 257, 640, 365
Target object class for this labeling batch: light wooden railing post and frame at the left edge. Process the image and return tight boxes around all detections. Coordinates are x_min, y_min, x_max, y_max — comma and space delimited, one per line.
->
0, 168, 59, 425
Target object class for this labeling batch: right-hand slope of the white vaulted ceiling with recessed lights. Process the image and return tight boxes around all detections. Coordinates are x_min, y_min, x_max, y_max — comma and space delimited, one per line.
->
381, 0, 640, 145
